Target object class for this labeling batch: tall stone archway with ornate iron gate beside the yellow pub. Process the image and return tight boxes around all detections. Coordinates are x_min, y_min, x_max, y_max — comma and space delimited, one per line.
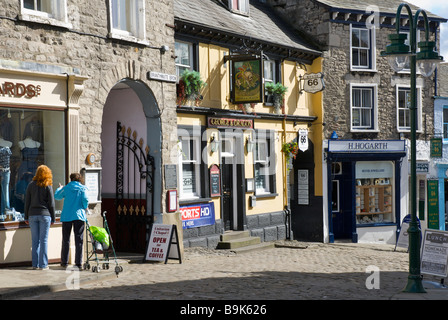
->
101, 79, 162, 253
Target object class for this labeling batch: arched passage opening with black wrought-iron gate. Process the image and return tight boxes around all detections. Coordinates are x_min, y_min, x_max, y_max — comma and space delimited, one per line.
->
101, 79, 162, 253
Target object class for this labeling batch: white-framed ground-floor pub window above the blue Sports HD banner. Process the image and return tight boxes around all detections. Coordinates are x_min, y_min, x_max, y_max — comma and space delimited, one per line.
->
179, 136, 201, 200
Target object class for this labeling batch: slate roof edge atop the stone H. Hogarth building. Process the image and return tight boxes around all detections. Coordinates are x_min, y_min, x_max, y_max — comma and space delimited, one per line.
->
315, 0, 447, 22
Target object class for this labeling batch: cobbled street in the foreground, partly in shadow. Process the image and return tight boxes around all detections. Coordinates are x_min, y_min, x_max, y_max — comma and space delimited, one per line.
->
21, 243, 440, 300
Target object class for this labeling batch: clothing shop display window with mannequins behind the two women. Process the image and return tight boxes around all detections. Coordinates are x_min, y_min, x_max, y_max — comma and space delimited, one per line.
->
0, 108, 65, 222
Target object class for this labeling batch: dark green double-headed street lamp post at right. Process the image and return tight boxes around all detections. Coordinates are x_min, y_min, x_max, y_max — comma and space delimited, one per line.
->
381, 3, 443, 293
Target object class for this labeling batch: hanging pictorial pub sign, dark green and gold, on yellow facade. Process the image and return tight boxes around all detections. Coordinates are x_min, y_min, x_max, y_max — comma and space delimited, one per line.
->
230, 56, 263, 104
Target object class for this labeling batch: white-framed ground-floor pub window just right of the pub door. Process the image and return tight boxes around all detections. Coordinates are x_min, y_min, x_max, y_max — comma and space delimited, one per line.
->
254, 132, 276, 195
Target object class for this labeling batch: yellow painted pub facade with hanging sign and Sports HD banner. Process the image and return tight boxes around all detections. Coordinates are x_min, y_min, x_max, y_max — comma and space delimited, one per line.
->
173, 1, 323, 247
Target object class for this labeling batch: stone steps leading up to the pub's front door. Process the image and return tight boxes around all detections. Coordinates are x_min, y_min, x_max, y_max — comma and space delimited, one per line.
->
216, 230, 274, 253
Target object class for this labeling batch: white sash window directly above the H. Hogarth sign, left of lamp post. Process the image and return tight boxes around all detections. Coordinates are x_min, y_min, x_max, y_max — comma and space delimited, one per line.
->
351, 86, 377, 131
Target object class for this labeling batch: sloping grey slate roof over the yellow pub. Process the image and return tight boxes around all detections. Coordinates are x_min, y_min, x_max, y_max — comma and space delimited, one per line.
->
174, 0, 321, 60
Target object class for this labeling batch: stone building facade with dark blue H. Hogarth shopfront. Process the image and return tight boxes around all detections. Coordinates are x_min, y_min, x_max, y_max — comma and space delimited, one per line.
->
268, 0, 446, 243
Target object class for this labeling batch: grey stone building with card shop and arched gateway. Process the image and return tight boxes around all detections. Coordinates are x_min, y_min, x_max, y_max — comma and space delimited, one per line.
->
0, 0, 180, 264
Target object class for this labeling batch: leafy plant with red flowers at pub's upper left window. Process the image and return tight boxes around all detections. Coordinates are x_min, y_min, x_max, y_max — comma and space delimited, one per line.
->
177, 69, 206, 107
